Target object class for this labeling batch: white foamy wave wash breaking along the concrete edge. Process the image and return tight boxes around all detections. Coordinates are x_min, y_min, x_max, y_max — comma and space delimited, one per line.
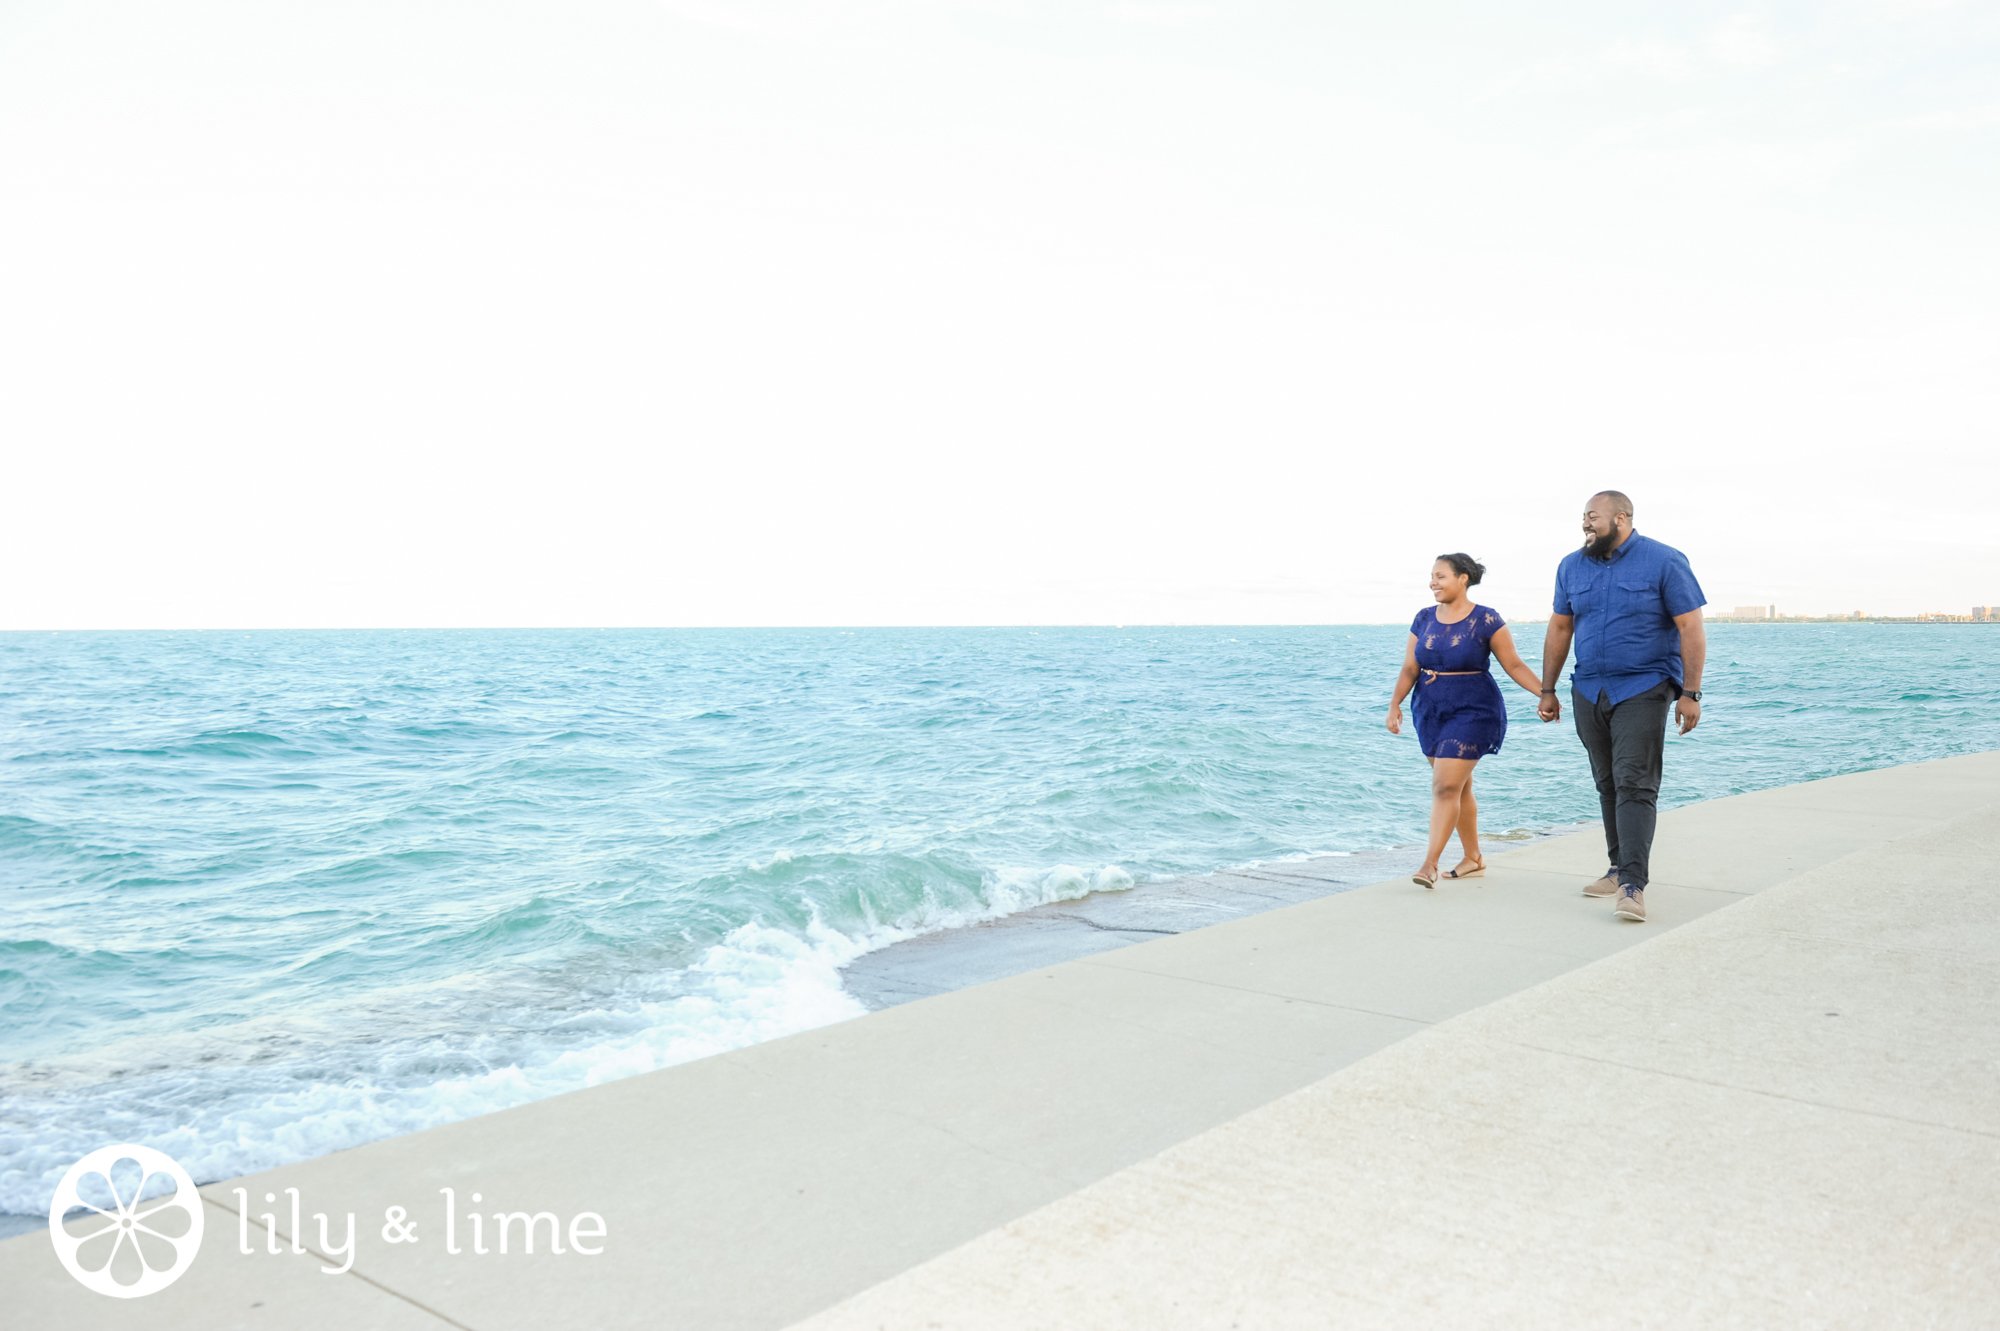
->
0, 851, 1132, 1215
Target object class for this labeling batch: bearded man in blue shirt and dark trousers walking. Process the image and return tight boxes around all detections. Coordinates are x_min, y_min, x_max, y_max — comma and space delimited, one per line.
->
1540, 490, 1708, 919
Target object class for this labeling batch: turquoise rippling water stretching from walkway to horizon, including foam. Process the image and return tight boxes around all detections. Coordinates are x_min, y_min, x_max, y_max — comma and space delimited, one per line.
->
0, 624, 2000, 1213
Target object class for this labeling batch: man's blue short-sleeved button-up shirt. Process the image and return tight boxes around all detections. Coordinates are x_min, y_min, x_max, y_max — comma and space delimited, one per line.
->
1556, 532, 1708, 705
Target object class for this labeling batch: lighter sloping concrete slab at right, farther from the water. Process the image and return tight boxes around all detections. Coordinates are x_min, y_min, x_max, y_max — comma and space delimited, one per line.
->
802, 755, 2000, 1331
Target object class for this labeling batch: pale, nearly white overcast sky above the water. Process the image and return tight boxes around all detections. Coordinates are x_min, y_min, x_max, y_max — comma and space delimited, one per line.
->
0, 0, 2000, 630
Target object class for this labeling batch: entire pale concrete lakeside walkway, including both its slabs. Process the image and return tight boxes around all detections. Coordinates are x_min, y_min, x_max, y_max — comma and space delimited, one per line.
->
0, 753, 2000, 1331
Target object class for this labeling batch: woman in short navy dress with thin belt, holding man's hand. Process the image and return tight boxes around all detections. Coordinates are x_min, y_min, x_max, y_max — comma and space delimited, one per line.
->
1388, 554, 1542, 887
